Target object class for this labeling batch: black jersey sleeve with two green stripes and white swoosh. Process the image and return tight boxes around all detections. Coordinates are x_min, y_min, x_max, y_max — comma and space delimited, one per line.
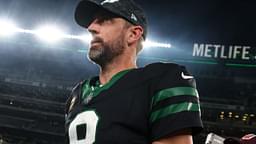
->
149, 64, 203, 141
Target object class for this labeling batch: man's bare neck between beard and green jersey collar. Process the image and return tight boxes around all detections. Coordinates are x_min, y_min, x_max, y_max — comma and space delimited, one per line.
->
99, 56, 137, 85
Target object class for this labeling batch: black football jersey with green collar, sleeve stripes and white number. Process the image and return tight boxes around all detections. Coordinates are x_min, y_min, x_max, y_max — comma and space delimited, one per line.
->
66, 63, 202, 144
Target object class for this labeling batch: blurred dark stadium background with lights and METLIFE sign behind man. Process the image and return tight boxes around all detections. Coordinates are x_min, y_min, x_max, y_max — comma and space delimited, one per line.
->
0, 0, 256, 144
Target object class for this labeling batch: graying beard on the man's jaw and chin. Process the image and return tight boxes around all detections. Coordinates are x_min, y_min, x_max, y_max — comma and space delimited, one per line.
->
88, 35, 124, 69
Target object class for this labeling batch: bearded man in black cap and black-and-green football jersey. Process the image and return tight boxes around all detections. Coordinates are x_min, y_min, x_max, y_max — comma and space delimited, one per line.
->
66, 0, 202, 144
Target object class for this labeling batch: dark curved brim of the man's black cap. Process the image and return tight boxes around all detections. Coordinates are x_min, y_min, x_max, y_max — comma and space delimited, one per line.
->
75, 0, 100, 28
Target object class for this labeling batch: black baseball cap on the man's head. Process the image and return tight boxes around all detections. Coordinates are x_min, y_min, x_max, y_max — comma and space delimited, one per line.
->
75, 0, 147, 39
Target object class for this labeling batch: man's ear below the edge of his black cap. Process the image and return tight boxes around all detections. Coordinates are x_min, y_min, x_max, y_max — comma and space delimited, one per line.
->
127, 26, 143, 45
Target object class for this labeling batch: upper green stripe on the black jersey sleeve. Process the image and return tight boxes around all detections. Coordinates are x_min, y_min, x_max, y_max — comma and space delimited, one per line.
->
152, 87, 198, 106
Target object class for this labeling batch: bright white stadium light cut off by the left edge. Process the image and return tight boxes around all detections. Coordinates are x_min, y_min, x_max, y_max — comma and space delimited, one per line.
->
0, 20, 19, 36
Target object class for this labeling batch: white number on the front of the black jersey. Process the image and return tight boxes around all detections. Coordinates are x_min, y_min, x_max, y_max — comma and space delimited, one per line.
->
68, 111, 99, 144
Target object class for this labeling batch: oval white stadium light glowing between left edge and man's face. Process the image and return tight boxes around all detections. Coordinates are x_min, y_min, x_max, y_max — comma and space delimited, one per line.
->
34, 25, 65, 42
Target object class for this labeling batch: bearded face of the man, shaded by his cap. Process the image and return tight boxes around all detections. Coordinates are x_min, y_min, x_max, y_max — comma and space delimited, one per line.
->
88, 11, 130, 67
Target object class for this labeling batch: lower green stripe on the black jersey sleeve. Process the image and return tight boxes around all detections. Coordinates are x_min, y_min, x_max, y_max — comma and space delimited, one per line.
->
150, 102, 200, 122
